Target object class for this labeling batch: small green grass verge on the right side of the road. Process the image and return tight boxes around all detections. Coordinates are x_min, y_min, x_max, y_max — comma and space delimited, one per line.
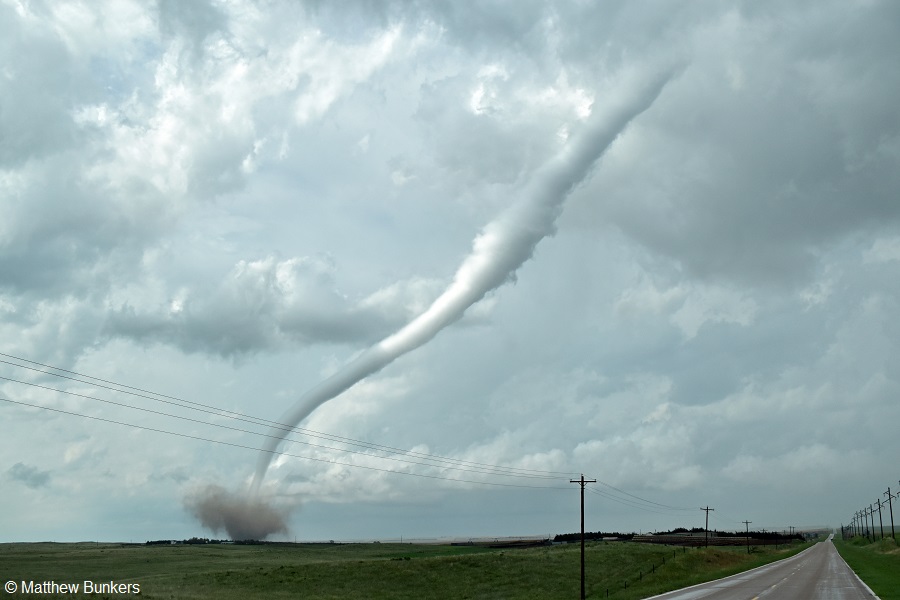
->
834, 537, 900, 600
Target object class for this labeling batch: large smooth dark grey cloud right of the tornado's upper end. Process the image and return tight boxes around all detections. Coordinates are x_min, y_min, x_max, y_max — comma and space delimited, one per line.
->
568, 3, 900, 285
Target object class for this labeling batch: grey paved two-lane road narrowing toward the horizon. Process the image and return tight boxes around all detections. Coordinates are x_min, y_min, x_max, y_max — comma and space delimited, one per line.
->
653, 538, 877, 600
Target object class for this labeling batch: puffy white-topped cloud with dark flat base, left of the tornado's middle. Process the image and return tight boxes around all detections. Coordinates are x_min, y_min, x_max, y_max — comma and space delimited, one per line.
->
103, 257, 444, 356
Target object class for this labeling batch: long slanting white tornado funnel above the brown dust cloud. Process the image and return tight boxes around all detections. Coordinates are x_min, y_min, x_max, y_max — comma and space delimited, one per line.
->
250, 68, 672, 495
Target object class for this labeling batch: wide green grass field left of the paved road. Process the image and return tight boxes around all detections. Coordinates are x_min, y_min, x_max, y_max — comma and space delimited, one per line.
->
0, 542, 805, 600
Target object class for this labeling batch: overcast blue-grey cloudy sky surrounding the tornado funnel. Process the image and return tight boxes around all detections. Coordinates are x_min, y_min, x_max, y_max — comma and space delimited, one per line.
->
0, 0, 900, 541
